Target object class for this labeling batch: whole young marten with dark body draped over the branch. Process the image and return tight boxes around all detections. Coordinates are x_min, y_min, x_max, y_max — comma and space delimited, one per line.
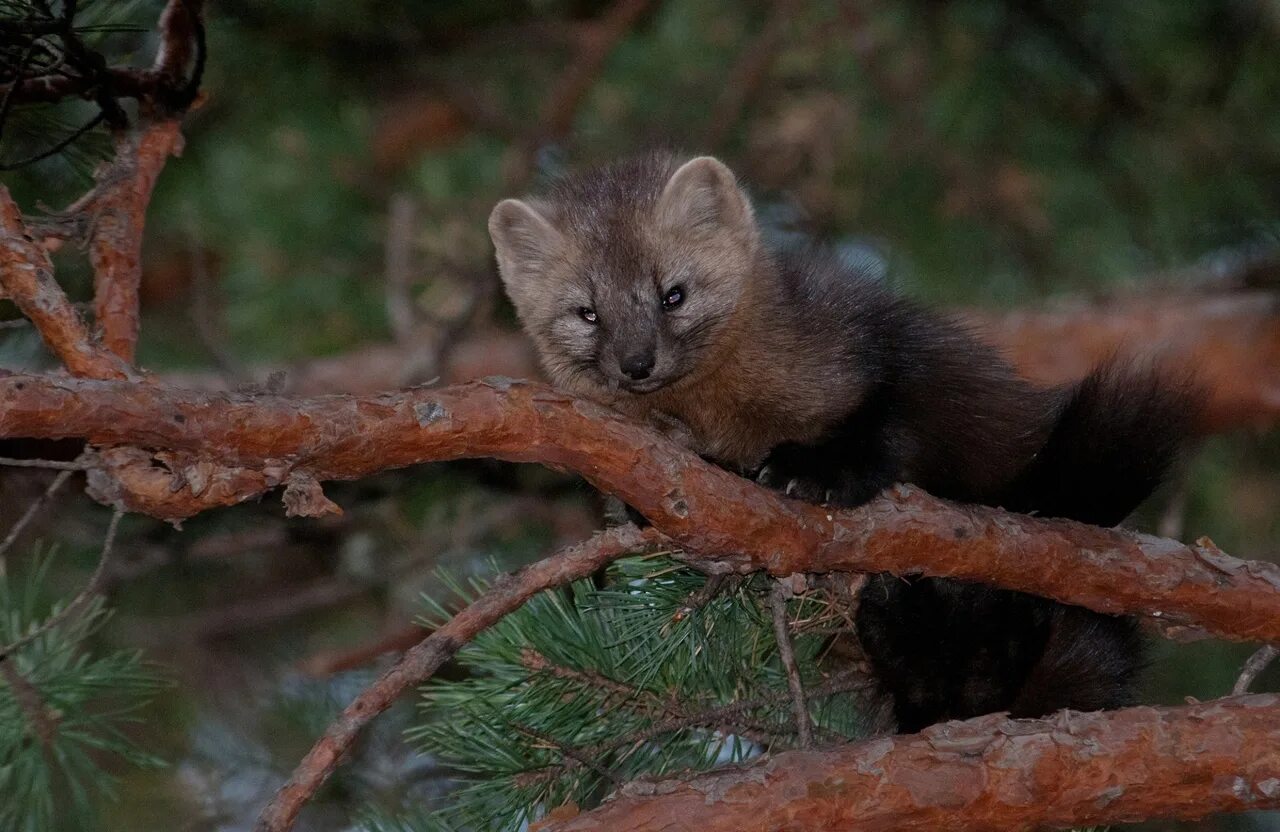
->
489, 152, 1198, 732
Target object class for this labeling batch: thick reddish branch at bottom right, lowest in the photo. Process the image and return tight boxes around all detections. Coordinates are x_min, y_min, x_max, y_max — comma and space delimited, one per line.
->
532, 695, 1280, 832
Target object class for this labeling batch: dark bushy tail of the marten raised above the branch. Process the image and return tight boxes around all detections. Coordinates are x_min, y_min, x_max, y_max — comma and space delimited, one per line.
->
998, 360, 1203, 526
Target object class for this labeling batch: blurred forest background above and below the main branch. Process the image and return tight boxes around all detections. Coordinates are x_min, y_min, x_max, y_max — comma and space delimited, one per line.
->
0, 0, 1280, 831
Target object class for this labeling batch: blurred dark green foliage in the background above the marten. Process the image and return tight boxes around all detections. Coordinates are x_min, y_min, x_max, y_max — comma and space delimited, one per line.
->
10, 0, 1280, 355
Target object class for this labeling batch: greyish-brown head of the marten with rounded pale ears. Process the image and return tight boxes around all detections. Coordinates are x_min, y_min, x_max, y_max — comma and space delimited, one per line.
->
489, 155, 760, 398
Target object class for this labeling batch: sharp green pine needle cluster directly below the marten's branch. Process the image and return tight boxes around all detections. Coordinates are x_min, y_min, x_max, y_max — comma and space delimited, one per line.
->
389, 556, 880, 832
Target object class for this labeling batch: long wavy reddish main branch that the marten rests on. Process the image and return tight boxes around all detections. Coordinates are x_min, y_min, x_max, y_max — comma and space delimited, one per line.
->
0, 375, 1280, 641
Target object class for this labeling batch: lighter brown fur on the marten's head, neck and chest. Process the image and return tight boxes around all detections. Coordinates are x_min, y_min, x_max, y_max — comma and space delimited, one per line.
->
490, 155, 863, 468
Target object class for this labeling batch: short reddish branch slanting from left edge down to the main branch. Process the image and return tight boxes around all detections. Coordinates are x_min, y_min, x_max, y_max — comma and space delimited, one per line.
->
0, 186, 129, 379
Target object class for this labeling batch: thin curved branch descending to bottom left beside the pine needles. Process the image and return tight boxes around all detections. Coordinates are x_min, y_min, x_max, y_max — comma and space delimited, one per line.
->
253, 526, 659, 832
